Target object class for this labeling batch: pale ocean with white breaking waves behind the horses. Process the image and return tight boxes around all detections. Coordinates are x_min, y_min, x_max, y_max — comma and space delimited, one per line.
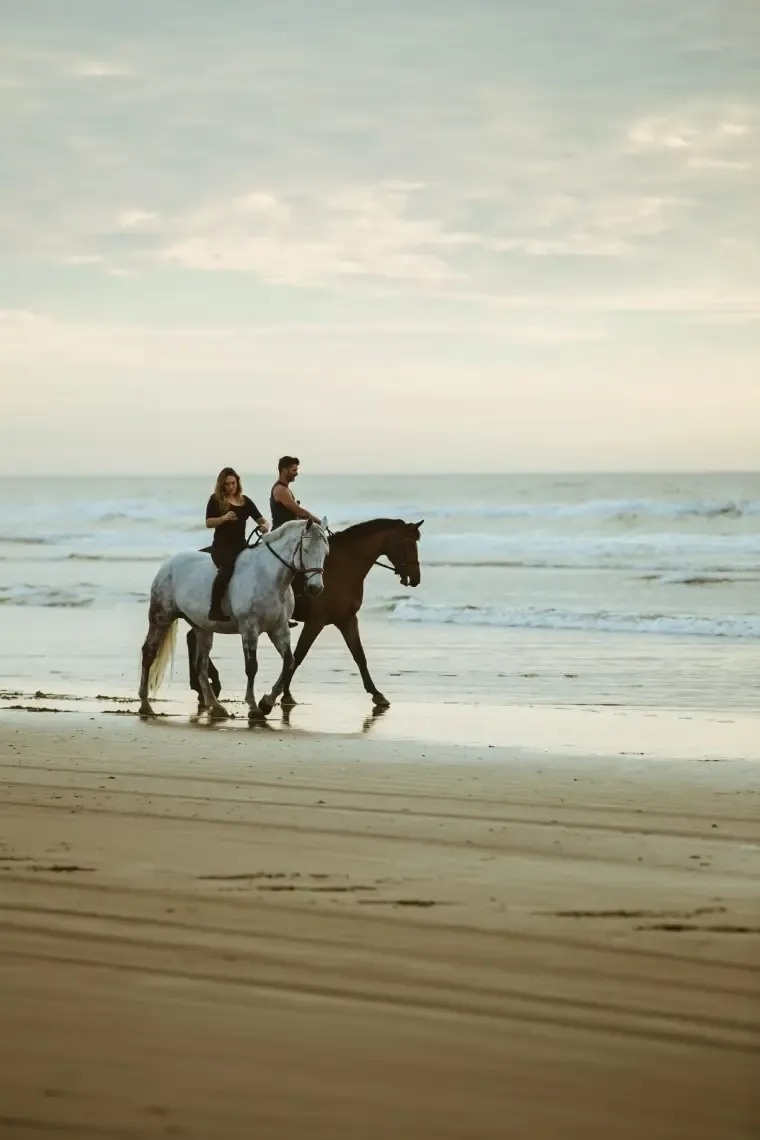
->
0, 472, 760, 747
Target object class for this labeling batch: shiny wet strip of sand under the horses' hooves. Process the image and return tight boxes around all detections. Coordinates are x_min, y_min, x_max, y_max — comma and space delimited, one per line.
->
0, 690, 760, 763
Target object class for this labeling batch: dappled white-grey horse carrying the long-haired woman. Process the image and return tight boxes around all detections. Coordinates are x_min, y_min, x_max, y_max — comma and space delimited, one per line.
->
139, 519, 329, 720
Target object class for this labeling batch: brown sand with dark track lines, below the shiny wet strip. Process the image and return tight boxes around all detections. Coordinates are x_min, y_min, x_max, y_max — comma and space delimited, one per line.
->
0, 713, 760, 1140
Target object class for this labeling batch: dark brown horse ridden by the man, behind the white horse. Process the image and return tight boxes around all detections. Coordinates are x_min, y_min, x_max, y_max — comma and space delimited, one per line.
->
187, 519, 424, 708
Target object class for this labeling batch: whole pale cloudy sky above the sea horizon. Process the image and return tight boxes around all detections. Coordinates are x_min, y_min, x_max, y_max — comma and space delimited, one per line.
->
0, 0, 760, 475
